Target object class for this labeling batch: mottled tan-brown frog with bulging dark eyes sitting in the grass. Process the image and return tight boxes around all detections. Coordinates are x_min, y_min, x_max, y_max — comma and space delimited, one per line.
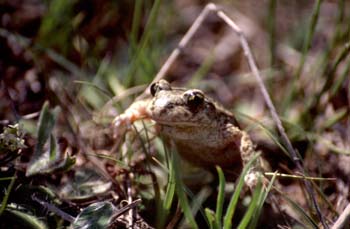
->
113, 79, 259, 186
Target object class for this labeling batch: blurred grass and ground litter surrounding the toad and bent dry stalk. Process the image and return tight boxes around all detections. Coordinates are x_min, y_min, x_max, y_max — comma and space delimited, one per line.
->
0, 0, 350, 228
